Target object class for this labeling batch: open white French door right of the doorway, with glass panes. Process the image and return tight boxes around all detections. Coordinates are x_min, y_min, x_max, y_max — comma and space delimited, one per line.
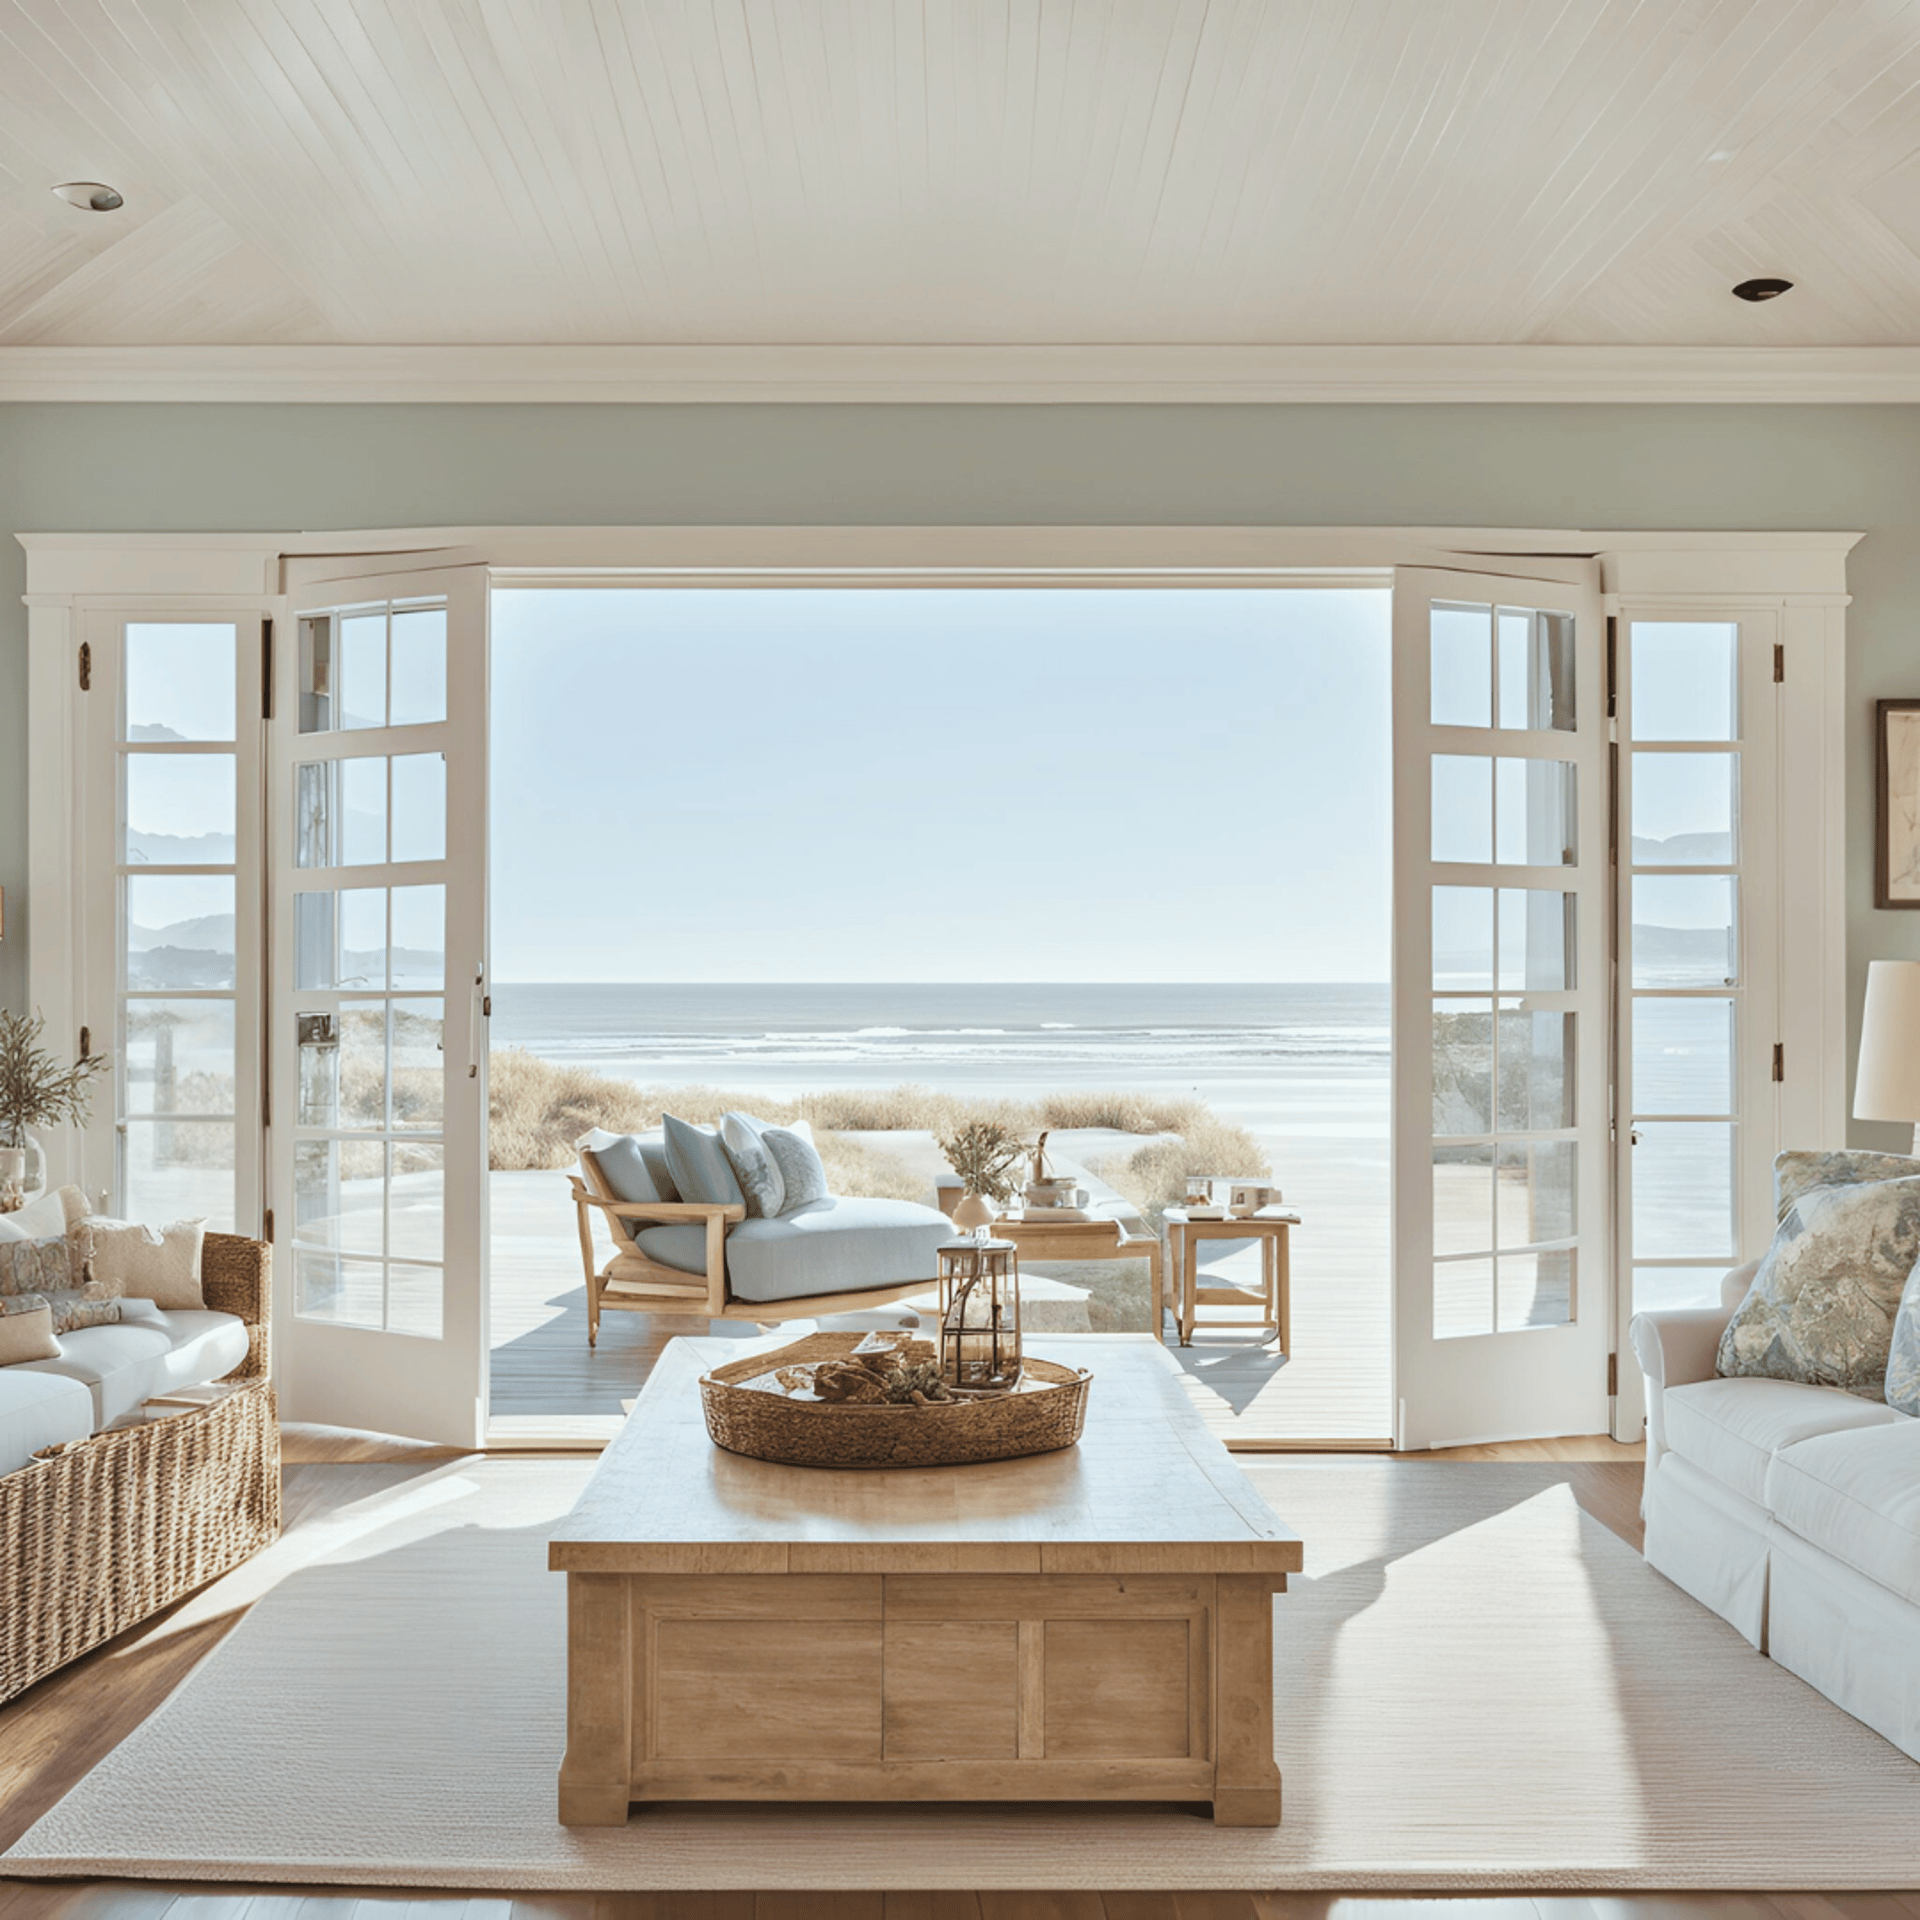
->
1394, 563, 1613, 1448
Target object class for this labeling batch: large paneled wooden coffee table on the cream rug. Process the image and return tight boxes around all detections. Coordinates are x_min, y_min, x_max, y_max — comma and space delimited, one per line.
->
547, 1334, 1300, 1826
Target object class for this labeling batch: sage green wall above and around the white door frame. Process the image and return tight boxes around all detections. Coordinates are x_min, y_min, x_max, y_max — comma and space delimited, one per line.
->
0, 405, 1920, 1144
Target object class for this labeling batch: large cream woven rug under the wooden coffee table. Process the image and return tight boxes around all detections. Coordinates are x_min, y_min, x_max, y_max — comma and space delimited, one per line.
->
0, 1461, 1920, 1891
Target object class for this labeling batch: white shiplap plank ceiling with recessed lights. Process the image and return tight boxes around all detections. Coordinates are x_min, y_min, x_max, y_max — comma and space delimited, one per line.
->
0, 0, 1920, 359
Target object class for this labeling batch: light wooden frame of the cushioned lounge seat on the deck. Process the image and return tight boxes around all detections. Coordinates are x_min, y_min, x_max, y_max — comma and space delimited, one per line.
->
570, 1154, 935, 1346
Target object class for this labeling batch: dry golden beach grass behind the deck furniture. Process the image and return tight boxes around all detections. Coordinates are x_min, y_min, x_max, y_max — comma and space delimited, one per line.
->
488, 1046, 1269, 1215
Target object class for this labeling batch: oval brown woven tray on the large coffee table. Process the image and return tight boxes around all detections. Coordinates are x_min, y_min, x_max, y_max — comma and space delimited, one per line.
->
701, 1332, 1092, 1467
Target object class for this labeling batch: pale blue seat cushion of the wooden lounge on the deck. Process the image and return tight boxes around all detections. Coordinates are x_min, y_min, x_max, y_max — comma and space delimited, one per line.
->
639, 1198, 954, 1300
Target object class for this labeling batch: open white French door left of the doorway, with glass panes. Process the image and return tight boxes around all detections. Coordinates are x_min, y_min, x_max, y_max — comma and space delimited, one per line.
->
267, 566, 488, 1446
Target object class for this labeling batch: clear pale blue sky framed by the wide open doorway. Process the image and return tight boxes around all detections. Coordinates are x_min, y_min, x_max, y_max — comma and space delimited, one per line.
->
492, 588, 1390, 981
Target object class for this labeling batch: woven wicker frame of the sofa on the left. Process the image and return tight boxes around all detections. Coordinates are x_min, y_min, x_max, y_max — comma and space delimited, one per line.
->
0, 1233, 280, 1701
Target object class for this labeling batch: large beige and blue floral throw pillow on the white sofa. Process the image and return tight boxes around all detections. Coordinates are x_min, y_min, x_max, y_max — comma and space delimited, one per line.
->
1718, 1177, 1920, 1400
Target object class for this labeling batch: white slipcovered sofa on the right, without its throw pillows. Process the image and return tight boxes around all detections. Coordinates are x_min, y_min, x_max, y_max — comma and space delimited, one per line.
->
1630, 1265, 1920, 1761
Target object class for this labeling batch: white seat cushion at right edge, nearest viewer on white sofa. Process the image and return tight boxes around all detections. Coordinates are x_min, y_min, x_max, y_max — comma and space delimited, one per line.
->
1766, 1413, 1920, 1605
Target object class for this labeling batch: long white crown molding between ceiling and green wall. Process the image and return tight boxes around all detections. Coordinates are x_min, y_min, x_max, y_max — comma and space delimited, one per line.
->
0, 346, 1920, 405
